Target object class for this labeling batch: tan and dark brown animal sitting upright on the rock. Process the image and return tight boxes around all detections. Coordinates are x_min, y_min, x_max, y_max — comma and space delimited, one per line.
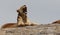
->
17, 5, 31, 26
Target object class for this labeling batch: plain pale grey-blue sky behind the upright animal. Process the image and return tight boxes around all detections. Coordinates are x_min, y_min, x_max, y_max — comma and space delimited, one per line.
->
0, 0, 60, 25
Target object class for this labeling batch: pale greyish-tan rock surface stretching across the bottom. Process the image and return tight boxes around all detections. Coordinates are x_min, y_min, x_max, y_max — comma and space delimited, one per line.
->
0, 24, 60, 35
